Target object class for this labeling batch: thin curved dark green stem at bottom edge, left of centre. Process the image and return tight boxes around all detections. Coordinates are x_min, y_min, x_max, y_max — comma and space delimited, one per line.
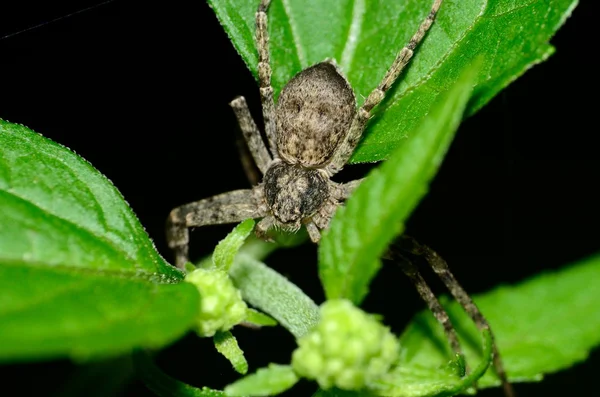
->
133, 351, 225, 397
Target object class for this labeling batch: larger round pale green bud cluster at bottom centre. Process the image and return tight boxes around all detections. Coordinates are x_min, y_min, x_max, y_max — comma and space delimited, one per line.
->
292, 300, 399, 390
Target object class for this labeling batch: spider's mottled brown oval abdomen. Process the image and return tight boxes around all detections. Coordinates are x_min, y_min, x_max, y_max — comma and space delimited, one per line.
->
276, 62, 356, 167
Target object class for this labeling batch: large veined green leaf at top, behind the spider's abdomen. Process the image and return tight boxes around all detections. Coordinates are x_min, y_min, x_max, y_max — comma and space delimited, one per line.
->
209, 0, 577, 162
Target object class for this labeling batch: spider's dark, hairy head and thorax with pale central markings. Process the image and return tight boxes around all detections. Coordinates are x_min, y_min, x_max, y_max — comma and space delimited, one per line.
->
263, 162, 329, 227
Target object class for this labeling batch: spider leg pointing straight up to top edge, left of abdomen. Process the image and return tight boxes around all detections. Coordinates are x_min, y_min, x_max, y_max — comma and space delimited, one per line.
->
256, 0, 277, 157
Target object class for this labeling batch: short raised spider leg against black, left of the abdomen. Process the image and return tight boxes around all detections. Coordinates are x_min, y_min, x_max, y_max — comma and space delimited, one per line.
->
229, 96, 272, 177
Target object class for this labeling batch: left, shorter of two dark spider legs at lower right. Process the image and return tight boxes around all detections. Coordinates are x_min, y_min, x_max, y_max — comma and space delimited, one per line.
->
384, 245, 462, 354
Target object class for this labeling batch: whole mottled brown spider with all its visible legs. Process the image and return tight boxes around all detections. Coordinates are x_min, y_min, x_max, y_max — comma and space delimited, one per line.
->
167, 0, 513, 396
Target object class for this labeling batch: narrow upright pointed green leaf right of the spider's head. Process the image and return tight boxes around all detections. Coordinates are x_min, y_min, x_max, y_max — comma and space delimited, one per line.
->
319, 64, 478, 304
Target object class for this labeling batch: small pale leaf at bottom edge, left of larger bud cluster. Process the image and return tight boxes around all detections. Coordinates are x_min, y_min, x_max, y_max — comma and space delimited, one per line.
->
225, 364, 298, 397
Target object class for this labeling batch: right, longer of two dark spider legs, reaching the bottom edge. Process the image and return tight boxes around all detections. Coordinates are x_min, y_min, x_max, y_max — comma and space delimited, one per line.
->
402, 236, 515, 397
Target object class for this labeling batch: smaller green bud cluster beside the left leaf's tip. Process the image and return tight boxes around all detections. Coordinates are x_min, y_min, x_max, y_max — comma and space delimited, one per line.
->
185, 268, 248, 336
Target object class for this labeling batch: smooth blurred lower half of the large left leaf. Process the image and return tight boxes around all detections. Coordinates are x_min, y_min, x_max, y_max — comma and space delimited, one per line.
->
0, 260, 199, 361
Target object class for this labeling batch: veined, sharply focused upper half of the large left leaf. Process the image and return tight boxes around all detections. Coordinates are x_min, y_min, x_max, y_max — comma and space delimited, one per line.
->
0, 120, 183, 282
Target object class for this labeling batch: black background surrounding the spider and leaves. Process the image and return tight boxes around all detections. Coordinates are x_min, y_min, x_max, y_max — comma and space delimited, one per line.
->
0, 0, 600, 396
